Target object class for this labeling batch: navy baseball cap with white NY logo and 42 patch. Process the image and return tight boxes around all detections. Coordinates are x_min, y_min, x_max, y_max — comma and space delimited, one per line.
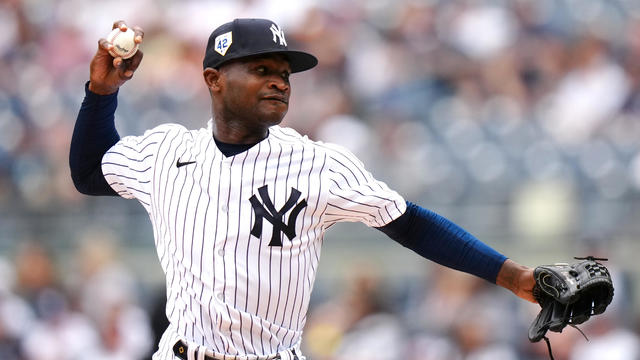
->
202, 19, 318, 73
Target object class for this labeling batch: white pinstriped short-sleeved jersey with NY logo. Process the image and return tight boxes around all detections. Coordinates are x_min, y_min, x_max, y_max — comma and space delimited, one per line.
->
102, 124, 406, 360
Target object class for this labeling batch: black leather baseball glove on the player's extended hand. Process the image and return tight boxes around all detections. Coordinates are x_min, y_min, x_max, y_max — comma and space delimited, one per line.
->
529, 256, 613, 358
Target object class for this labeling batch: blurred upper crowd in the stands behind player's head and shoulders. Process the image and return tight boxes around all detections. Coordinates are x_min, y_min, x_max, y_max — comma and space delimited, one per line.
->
0, 0, 640, 209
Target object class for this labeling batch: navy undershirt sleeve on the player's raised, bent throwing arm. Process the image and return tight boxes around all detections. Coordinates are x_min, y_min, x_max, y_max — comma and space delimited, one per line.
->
69, 82, 120, 196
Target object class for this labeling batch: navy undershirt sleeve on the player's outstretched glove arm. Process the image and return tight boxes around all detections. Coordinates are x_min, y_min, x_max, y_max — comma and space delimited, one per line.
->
377, 201, 507, 283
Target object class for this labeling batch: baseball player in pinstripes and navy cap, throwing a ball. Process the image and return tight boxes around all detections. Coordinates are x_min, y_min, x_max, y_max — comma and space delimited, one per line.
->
69, 19, 535, 360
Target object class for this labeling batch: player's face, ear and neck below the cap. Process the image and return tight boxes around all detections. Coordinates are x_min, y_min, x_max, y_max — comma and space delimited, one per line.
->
203, 54, 291, 144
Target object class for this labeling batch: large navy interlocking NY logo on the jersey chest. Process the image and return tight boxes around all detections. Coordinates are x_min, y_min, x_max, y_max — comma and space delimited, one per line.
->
249, 185, 307, 246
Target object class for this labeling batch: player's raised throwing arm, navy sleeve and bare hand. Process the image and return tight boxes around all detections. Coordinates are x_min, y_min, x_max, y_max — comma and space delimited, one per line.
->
69, 21, 144, 195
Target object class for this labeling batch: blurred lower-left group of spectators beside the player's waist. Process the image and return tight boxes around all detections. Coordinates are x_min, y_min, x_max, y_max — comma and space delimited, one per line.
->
0, 232, 156, 360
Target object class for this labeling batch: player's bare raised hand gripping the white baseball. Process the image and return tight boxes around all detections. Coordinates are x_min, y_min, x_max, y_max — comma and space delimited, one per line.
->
89, 20, 144, 95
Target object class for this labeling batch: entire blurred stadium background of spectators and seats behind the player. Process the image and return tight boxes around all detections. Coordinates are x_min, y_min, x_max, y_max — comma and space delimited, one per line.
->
0, 0, 640, 360
